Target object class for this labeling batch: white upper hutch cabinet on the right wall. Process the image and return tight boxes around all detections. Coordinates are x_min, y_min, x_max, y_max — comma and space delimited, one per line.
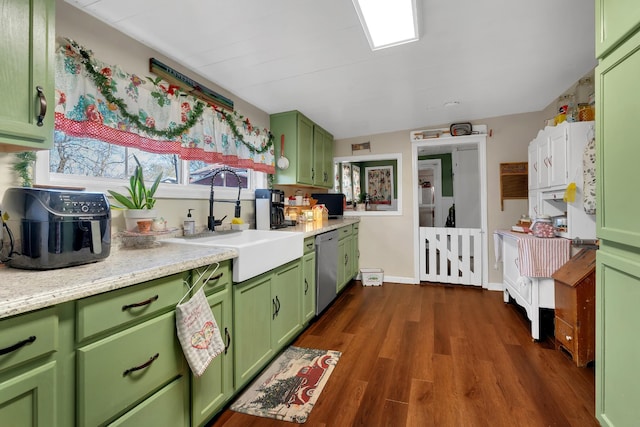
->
528, 122, 596, 239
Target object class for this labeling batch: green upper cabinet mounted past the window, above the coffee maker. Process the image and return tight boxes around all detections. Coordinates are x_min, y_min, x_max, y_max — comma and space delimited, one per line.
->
270, 111, 333, 188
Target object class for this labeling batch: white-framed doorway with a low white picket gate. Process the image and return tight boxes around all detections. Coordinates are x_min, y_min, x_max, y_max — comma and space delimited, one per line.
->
412, 132, 488, 287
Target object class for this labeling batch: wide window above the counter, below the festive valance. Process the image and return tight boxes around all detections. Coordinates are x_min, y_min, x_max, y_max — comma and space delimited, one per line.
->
36, 138, 267, 198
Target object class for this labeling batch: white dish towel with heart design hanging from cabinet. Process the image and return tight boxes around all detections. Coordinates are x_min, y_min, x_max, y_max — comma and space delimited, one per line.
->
176, 288, 224, 377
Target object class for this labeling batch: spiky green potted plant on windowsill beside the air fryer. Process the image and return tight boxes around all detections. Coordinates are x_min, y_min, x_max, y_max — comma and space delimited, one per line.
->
108, 156, 162, 230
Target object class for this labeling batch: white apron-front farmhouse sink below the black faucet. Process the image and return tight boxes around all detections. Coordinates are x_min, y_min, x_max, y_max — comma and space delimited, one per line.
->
164, 230, 304, 282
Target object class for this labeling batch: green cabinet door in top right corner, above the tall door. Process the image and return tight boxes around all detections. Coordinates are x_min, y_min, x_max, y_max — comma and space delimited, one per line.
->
596, 0, 640, 58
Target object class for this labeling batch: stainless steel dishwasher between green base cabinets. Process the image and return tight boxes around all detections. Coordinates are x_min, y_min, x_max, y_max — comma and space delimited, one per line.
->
316, 230, 338, 315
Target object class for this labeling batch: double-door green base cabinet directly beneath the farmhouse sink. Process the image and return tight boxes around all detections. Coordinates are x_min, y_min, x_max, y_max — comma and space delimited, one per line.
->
233, 259, 303, 389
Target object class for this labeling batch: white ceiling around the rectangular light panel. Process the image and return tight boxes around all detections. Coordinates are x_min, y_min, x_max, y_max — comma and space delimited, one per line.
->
65, 0, 596, 138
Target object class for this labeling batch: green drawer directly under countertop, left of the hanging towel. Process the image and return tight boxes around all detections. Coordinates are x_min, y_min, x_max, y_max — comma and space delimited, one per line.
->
76, 274, 188, 341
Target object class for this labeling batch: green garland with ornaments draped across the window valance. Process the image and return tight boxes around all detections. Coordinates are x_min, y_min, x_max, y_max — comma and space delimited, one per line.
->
67, 39, 273, 154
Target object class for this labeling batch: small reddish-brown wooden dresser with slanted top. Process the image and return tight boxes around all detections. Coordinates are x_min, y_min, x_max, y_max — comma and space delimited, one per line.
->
552, 249, 596, 367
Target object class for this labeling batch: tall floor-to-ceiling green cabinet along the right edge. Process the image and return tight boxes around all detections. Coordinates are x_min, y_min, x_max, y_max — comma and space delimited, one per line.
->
596, 0, 640, 427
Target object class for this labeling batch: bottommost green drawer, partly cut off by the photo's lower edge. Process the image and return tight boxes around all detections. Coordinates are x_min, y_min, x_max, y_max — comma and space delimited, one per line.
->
109, 377, 189, 427
